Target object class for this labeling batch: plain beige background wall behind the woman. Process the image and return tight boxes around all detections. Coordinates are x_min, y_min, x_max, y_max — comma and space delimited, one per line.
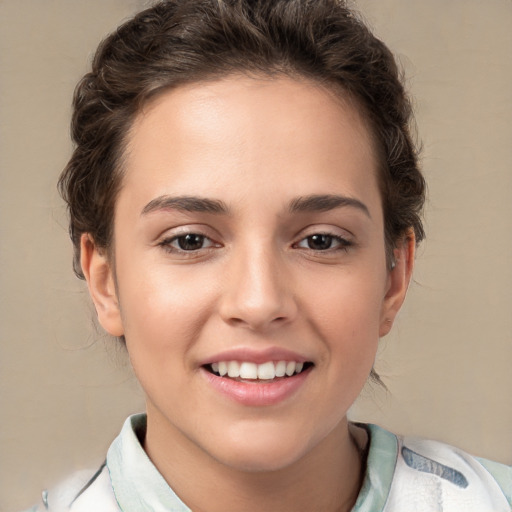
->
0, 0, 512, 512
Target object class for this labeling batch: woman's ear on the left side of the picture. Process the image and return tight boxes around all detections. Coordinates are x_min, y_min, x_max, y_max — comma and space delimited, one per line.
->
80, 233, 124, 336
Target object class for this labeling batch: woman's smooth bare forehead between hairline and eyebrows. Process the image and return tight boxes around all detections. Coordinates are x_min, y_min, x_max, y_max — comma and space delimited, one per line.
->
122, 76, 377, 217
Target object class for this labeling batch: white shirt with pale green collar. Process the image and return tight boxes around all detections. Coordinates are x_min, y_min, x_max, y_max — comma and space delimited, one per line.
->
27, 414, 512, 512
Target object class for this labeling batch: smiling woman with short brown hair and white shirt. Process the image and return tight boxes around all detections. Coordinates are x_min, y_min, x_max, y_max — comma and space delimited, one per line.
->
27, 0, 512, 512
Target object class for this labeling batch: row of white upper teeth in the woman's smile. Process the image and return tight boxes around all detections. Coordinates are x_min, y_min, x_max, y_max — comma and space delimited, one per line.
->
211, 361, 304, 380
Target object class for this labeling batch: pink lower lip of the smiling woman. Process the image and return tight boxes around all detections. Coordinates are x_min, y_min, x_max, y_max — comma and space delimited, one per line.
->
201, 367, 312, 406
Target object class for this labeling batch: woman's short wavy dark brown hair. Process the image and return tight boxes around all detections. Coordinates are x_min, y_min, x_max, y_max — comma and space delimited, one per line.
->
59, 0, 425, 278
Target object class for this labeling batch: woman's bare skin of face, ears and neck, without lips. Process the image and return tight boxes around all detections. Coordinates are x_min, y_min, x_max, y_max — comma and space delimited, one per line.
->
82, 76, 414, 512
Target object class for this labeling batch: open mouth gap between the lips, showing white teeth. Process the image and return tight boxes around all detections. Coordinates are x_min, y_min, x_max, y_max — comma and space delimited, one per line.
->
203, 361, 314, 383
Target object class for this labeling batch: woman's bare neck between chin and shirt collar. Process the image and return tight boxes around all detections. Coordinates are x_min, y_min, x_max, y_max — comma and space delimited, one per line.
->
144, 411, 362, 512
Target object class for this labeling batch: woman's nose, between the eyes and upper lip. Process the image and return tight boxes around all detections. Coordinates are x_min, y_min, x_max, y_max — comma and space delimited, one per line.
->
220, 245, 297, 331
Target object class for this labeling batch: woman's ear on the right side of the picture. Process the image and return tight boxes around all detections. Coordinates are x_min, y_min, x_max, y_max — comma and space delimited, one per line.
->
379, 230, 416, 337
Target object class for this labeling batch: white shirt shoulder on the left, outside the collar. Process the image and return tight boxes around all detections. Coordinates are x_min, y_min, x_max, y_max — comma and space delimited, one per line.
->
29, 464, 121, 512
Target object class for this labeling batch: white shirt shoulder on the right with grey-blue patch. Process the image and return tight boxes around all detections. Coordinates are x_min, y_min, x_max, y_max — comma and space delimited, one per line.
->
360, 426, 512, 512
